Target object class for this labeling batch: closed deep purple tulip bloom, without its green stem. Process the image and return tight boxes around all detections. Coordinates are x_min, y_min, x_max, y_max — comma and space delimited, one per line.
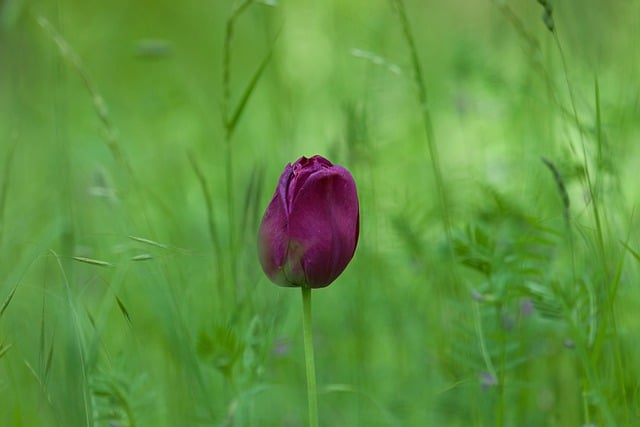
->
258, 156, 360, 288
